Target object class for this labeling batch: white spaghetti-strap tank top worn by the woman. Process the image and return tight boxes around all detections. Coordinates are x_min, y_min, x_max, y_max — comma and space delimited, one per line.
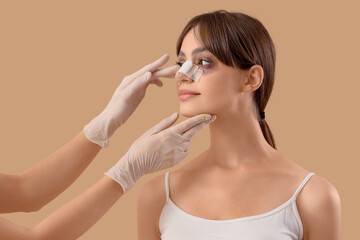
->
159, 172, 315, 240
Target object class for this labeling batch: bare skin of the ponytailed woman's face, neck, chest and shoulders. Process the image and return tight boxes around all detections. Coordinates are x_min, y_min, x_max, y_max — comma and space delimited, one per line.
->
138, 30, 341, 240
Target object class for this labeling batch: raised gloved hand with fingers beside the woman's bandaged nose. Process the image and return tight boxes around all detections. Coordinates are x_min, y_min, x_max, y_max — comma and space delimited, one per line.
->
83, 54, 179, 147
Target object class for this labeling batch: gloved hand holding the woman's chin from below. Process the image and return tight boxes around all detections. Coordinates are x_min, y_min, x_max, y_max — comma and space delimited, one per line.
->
105, 113, 216, 194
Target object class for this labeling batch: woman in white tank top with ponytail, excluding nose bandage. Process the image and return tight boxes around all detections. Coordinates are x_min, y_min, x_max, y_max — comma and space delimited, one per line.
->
138, 11, 341, 240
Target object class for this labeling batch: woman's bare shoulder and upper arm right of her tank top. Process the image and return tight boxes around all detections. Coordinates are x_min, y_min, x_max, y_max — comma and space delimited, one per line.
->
296, 175, 341, 240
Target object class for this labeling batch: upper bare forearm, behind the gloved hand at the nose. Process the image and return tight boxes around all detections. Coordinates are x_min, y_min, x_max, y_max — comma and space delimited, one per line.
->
0, 131, 101, 213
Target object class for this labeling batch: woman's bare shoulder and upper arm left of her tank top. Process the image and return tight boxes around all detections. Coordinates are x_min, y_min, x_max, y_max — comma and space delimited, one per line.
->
137, 174, 166, 240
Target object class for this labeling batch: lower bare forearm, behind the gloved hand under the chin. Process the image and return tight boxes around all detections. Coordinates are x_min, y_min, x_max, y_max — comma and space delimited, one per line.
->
0, 176, 123, 240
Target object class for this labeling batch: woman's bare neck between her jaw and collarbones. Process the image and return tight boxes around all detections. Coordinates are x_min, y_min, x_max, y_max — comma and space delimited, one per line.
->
206, 115, 275, 168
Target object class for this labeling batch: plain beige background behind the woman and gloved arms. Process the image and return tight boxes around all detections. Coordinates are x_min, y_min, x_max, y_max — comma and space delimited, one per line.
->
0, 0, 360, 239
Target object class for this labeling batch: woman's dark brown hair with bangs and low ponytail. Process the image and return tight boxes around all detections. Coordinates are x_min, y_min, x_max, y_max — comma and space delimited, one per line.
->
176, 10, 276, 149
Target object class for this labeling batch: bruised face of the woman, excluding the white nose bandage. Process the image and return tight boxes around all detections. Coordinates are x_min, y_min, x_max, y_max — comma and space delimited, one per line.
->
176, 29, 249, 117
